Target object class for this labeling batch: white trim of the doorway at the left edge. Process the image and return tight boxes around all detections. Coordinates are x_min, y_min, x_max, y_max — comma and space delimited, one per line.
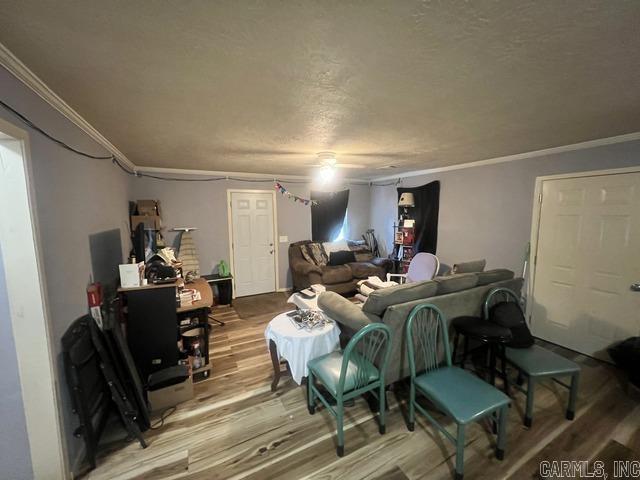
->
0, 119, 68, 479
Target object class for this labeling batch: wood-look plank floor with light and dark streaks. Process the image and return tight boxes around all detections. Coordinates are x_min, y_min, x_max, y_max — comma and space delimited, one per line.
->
86, 297, 640, 480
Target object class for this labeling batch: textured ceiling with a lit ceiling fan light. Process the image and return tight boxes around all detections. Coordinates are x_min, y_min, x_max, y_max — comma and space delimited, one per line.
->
0, 0, 640, 178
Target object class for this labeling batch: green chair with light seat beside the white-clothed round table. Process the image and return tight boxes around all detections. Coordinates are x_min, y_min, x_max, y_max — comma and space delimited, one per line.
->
307, 323, 391, 457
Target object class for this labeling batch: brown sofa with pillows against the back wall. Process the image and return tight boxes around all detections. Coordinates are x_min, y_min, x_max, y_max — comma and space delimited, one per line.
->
289, 240, 393, 294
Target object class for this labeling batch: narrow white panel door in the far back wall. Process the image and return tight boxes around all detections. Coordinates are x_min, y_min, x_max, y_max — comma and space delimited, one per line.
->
231, 192, 276, 297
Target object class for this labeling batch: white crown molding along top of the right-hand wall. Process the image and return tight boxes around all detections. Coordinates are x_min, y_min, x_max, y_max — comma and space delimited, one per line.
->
370, 132, 640, 182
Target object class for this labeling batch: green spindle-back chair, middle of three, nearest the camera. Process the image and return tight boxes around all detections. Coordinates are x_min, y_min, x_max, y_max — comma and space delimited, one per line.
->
406, 303, 510, 480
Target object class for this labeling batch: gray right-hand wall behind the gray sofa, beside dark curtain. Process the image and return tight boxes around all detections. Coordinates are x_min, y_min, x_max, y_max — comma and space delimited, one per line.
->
371, 141, 640, 272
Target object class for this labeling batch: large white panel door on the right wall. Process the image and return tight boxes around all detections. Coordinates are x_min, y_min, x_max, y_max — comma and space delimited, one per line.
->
531, 173, 640, 360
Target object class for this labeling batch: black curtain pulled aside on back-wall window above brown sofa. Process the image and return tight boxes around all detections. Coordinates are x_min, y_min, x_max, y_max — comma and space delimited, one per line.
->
311, 190, 349, 242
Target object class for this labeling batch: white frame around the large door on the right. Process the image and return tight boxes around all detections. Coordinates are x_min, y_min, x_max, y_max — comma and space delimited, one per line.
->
525, 166, 640, 326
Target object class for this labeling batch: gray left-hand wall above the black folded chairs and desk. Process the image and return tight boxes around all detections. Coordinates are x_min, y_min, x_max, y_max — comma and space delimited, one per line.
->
0, 64, 129, 472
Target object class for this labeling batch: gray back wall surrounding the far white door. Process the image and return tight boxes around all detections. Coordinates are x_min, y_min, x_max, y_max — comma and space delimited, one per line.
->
131, 178, 370, 288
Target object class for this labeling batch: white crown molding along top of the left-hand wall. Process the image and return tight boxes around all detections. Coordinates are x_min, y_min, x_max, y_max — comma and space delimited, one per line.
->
0, 43, 137, 170
